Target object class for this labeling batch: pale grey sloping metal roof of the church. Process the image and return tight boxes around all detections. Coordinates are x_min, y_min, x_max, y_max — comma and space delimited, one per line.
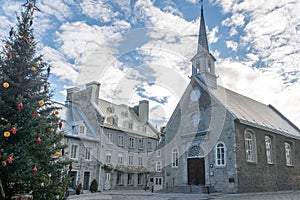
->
198, 80, 300, 138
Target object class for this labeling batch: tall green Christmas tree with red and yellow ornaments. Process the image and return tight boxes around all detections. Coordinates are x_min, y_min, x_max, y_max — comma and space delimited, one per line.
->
0, 0, 70, 199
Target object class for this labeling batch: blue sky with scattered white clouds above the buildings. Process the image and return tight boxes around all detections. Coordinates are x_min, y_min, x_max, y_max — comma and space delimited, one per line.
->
0, 0, 300, 127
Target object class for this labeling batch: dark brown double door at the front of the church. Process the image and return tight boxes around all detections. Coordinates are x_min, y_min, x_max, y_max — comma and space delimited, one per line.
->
187, 158, 205, 185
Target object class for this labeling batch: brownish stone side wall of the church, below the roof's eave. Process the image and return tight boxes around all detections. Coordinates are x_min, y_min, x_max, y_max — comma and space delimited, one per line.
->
236, 122, 300, 192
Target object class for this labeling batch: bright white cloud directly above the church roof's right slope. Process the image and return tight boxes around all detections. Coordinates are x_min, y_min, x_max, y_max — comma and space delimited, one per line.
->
217, 58, 300, 126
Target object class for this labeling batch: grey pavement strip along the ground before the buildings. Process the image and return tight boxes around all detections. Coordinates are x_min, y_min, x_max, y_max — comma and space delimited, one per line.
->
68, 190, 300, 200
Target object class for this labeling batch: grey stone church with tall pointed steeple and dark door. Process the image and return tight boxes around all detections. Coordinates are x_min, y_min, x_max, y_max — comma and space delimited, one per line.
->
160, 6, 300, 193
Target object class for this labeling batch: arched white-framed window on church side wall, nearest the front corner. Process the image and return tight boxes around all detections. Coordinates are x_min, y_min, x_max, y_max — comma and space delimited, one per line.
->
245, 129, 256, 162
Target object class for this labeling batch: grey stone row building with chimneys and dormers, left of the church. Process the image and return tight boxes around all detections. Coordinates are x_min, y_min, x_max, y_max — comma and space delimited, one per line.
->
63, 82, 159, 191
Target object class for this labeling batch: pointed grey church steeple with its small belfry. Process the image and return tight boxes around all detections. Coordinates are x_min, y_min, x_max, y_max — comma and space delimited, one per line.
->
191, 0, 217, 89
